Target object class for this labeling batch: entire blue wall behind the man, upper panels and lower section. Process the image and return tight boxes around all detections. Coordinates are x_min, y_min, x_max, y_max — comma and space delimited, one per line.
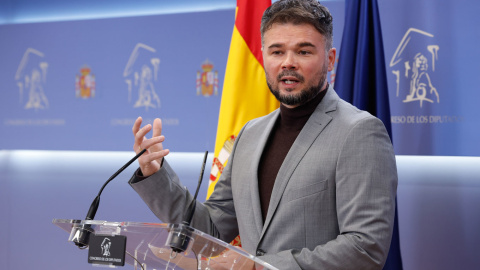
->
0, 0, 480, 269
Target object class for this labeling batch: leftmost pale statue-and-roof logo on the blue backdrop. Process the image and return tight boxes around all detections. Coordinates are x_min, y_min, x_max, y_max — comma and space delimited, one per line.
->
15, 48, 48, 110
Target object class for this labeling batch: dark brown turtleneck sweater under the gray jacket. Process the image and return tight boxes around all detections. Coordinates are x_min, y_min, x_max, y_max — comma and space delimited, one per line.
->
258, 84, 328, 222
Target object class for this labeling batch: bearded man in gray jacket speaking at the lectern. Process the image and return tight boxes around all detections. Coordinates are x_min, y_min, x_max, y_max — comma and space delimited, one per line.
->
130, 0, 397, 269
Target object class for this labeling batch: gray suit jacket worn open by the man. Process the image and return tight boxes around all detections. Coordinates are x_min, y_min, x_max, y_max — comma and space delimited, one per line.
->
130, 87, 397, 269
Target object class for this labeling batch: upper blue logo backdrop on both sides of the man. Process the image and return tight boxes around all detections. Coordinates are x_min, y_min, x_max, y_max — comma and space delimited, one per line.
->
0, 0, 480, 156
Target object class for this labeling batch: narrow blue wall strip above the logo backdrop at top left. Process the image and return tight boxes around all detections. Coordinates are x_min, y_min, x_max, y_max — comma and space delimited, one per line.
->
0, 0, 236, 24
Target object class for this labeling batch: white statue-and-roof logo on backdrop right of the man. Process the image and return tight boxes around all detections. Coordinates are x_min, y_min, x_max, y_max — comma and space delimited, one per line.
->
390, 28, 440, 107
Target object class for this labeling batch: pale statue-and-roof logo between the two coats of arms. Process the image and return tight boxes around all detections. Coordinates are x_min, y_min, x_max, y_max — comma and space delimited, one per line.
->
123, 43, 160, 110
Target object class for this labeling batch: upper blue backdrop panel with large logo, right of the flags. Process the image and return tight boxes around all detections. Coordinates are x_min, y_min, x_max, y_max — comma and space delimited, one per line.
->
379, 0, 480, 156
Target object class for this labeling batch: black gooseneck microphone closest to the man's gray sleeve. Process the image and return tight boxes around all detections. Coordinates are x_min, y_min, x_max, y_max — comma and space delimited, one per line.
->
167, 151, 208, 253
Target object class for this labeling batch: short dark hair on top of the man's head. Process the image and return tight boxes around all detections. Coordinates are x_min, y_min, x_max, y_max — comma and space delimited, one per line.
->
260, 0, 333, 51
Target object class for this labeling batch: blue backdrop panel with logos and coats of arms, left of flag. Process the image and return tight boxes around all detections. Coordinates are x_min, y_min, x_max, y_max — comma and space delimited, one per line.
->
0, 10, 234, 151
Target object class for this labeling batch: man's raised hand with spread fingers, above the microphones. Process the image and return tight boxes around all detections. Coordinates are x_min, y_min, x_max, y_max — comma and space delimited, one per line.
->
132, 117, 170, 176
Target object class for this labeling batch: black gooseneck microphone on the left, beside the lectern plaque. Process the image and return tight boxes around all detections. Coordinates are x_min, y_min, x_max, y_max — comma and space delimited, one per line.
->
72, 149, 147, 249
